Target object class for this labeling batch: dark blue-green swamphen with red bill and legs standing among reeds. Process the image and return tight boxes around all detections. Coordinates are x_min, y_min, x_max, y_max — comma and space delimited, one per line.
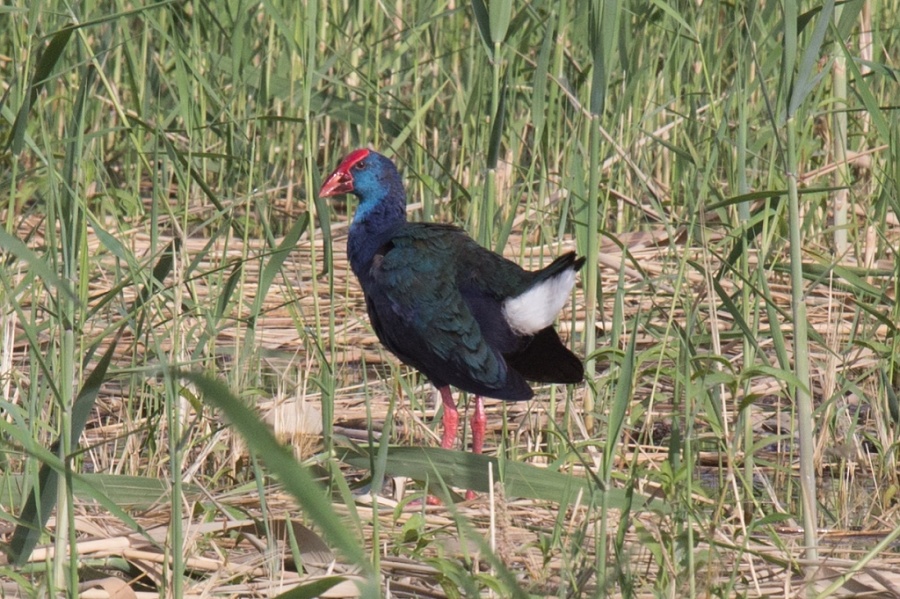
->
319, 149, 584, 464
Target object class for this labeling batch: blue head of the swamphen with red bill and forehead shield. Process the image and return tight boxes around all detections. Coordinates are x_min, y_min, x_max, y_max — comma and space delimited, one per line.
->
319, 148, 406, 204
